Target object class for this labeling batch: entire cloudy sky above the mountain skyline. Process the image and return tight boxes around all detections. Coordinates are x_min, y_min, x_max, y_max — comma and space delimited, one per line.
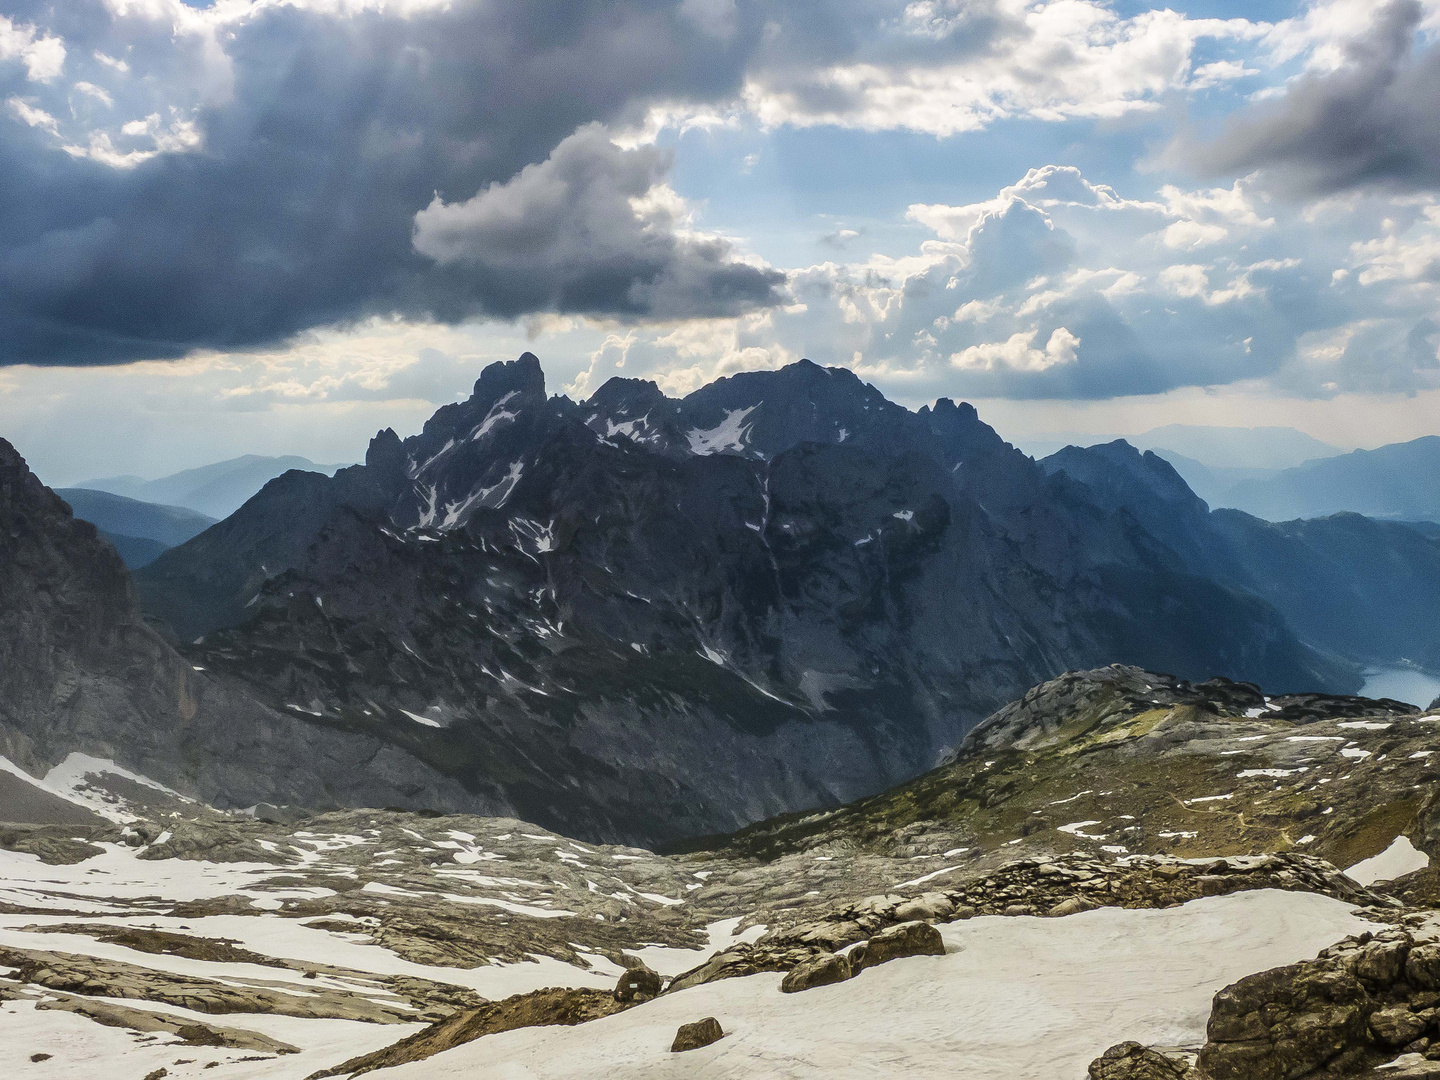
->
0, 0, 1440, 484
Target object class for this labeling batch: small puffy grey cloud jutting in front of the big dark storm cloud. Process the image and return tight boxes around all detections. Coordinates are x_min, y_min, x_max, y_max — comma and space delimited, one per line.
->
415, 124, 785, 318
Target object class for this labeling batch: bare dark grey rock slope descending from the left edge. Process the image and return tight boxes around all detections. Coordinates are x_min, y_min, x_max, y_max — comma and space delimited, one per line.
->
0, 439, 507, 812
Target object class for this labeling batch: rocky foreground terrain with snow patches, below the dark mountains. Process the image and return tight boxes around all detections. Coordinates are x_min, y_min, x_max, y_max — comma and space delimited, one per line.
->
0, 667, 1440, 1080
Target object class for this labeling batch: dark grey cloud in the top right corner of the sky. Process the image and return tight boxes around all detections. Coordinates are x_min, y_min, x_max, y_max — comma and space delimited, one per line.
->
1191, 0, 1440, 193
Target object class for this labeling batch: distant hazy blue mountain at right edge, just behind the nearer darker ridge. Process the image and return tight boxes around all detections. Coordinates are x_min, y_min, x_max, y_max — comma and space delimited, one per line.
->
1221, 435, 1440, 521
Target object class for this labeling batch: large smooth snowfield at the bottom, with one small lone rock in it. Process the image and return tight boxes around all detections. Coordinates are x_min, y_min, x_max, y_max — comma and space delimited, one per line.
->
377, 890, 1369, 1080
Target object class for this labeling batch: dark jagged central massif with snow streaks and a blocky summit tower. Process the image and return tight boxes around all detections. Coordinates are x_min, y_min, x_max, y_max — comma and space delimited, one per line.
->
118, 354, 1358, 842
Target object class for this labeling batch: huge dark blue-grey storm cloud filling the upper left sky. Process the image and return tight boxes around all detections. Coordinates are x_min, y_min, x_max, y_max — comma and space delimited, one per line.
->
0, 0, 776, 363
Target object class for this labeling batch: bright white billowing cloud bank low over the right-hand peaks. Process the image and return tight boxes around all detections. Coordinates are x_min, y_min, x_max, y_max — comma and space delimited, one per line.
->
539, 166, 1440, 400
